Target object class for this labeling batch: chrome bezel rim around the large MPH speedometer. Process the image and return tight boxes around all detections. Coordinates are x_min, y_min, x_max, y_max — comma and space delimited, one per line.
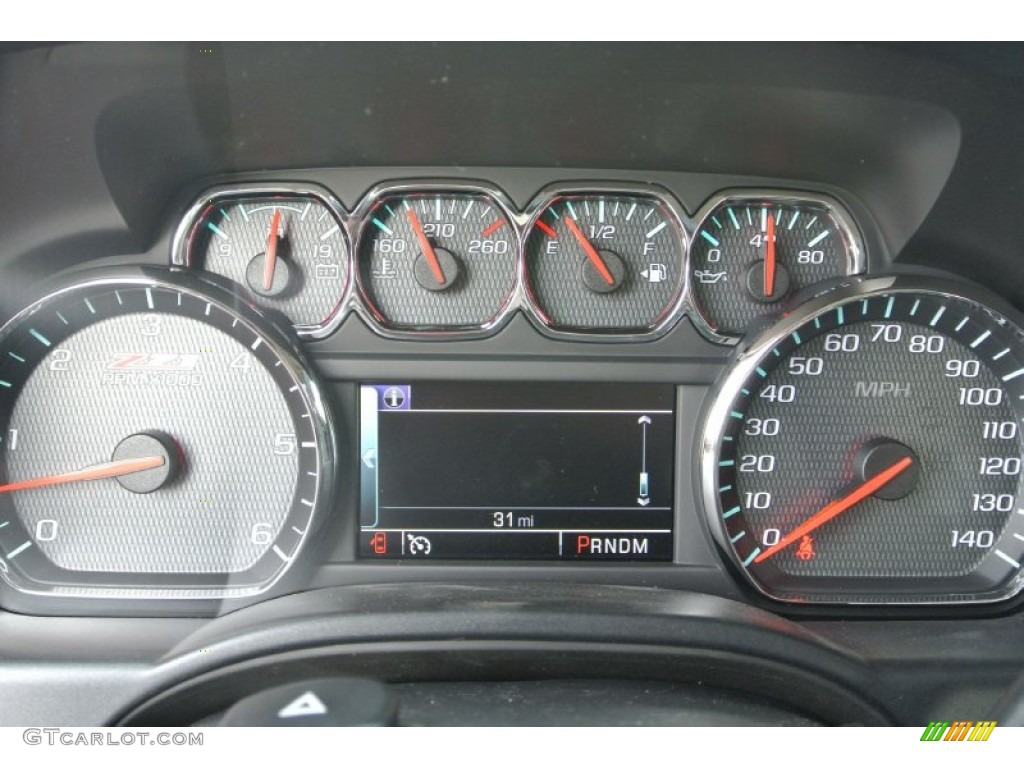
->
694, 274, 1024, 607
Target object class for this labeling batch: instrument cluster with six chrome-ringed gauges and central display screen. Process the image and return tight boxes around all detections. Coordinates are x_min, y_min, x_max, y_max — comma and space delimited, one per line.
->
0, 171, 1024, 612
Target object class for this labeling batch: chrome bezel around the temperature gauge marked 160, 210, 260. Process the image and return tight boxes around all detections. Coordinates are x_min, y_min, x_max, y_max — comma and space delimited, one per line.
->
348, 179, 522, 341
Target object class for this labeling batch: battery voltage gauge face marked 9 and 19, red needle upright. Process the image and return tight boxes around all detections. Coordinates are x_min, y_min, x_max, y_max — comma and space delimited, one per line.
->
185, 195, 348, 334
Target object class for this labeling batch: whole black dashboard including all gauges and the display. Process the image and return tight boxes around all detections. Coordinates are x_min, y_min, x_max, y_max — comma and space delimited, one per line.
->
0, 43, 1024, 725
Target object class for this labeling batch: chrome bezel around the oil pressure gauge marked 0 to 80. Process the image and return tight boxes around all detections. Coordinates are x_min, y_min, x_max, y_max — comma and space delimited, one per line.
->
684, 188, 867, 344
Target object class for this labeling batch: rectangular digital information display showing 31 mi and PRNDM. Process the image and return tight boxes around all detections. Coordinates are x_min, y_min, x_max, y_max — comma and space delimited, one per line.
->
359, 382, 675, 561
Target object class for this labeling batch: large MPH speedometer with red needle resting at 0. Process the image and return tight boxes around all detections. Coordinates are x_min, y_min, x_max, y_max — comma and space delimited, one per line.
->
703, 279, 1024, 602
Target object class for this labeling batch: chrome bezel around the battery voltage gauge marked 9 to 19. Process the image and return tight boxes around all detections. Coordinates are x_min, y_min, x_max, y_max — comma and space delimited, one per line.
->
170, 182, 354, 339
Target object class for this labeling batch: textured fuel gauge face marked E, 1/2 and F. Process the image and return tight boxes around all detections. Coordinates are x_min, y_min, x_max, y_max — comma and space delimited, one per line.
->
526, 195, 685, 334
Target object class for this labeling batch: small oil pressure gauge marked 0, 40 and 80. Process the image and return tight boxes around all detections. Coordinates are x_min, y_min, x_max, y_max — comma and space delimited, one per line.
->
690, 194, 863, 341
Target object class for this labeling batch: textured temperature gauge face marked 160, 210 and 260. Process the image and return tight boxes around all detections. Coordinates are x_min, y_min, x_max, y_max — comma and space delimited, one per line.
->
359, 193, 518, 332
